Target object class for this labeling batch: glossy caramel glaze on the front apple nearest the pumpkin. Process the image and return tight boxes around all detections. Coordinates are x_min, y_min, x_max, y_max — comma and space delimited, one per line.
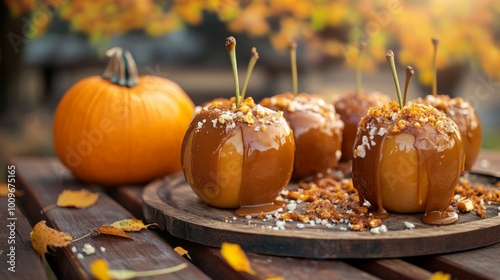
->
182, 100, 295, 216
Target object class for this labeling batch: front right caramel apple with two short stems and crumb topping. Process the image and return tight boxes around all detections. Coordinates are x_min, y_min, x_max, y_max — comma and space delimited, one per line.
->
352, 51, 465, 225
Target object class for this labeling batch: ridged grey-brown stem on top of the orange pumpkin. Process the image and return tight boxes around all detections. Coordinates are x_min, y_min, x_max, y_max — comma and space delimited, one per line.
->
102, 47, 139, 87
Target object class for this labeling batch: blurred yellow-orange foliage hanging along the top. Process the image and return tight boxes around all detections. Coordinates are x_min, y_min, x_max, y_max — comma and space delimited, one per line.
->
4, 0, 500, 84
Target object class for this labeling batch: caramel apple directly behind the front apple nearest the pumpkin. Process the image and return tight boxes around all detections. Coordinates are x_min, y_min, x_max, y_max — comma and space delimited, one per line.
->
260, 44, 344, 181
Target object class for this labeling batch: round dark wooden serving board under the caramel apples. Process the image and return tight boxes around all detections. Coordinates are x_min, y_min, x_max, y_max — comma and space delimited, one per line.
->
143, 174, 500, 259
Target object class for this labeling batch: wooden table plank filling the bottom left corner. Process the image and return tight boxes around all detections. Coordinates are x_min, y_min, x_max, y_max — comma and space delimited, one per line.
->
0, 197, 47, 280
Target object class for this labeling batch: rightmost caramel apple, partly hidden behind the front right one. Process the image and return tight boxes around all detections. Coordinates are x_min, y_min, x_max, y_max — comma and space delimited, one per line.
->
413, 38, 482, 170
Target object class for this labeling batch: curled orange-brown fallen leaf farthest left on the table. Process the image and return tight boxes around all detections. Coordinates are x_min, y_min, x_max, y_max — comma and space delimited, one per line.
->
30, 220, 73, 257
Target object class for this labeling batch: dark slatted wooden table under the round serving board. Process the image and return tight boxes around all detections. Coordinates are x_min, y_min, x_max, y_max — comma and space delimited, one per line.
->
0, 151, 500, 279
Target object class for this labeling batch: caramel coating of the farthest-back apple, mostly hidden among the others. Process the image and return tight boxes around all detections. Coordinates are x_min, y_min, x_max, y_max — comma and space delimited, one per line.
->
333, 92, 390, 161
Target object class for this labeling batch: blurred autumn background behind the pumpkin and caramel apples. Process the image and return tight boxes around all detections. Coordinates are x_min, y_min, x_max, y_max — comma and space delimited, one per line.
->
0, 0, 500, 174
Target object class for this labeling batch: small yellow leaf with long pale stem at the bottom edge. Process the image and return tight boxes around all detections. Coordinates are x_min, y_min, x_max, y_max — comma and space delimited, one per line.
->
90, 259, 187, 280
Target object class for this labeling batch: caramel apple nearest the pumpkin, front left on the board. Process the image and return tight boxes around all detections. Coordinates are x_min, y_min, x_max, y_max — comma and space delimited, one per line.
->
181, 37, 295, 216
